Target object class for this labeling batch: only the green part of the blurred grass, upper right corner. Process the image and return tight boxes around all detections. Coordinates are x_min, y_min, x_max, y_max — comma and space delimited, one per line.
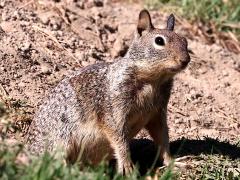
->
146, 0, 240, 34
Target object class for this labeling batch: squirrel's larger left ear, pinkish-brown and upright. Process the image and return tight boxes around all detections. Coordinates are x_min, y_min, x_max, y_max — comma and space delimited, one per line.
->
137, 9, 154, 36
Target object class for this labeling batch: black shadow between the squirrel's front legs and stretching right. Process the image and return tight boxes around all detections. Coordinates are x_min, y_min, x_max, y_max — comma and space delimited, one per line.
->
130, 138, 240, 174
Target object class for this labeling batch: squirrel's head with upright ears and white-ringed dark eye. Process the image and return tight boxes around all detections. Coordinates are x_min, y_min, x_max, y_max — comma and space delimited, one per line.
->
127, 10, 190, 79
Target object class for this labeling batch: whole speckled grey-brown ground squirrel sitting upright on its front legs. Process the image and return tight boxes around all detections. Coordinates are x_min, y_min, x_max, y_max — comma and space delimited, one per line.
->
27, 10, 190, 174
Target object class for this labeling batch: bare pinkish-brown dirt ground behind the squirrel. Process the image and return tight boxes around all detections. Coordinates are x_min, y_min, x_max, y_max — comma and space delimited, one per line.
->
0, 0, 240, 174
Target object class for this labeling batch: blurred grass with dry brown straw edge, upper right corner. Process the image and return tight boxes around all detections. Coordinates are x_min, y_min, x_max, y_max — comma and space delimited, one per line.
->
145, 0, 240, 52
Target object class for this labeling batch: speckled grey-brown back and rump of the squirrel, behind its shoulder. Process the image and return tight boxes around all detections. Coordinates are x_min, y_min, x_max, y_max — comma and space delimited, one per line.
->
27, 63, 108, 154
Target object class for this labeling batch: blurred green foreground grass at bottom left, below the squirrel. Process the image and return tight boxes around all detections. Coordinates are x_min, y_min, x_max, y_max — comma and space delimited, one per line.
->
0, 142, 177, 180
